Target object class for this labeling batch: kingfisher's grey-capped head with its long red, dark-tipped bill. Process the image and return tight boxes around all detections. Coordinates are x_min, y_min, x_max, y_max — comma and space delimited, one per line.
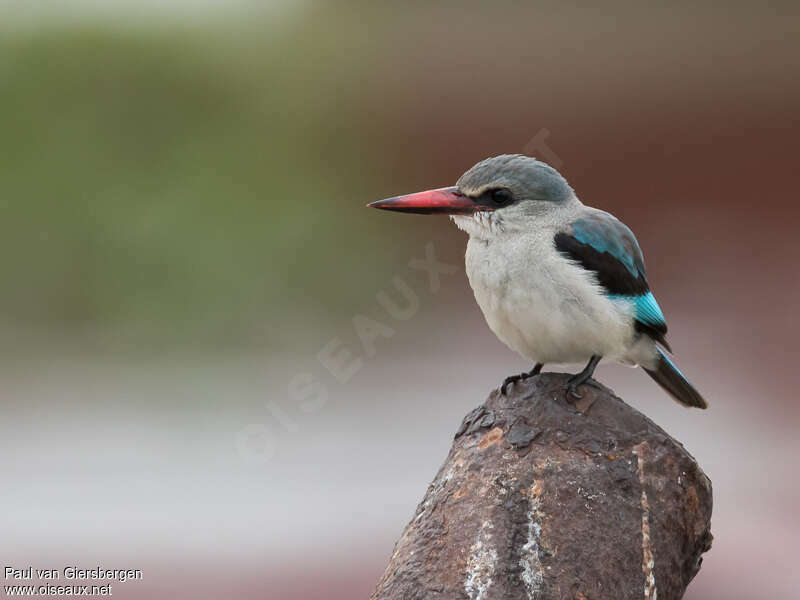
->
368, 154, 575, 235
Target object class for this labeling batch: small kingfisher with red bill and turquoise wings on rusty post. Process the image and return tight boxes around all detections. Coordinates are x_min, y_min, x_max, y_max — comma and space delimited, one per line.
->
367, 154, 708, 408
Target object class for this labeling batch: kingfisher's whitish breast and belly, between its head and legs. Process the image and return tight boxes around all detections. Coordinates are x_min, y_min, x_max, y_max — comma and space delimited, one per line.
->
466, 228, 634, 363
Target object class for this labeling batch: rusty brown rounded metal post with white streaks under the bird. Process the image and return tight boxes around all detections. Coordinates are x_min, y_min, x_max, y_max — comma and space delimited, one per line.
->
373, 373, 712, 600
